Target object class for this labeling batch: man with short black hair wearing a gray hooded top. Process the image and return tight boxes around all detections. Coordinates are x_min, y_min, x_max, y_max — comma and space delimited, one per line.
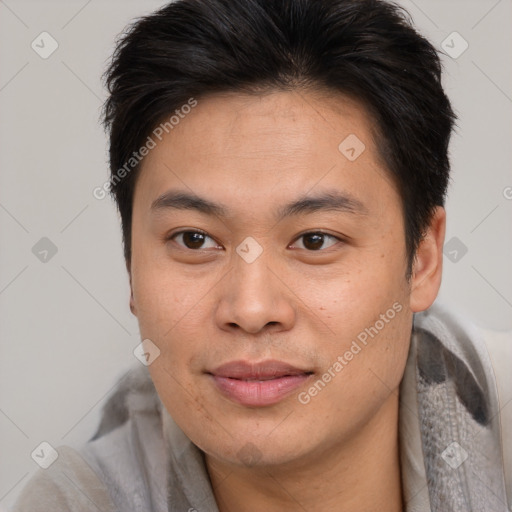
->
13, 0, 512, 512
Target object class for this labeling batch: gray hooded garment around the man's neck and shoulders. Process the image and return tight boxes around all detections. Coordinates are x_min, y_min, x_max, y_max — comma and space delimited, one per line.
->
13, 306, 512, 512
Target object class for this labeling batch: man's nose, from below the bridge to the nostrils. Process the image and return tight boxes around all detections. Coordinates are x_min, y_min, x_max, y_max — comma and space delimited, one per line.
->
215, 249, 296, 334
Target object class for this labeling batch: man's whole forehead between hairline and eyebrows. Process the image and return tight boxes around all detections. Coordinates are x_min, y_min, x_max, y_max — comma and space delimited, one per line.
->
135, 91, 397, 215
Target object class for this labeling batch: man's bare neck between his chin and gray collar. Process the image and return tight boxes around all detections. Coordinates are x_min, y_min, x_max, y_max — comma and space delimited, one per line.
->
206, 394, 402, 512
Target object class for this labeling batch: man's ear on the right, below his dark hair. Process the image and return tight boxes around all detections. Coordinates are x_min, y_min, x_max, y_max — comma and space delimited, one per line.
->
409, 206, 446, 313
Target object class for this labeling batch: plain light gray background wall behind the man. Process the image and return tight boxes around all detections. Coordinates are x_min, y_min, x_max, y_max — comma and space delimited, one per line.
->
0, 0, 512, 509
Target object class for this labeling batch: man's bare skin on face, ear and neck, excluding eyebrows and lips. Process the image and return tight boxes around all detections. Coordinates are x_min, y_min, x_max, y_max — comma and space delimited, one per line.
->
129, 91, 445, 512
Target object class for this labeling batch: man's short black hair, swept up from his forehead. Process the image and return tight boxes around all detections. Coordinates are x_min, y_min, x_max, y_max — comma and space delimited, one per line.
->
103, 0, 456, 275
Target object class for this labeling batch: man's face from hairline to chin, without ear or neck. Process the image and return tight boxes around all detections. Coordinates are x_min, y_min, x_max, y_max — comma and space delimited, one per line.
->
130, 92, 420, 465
